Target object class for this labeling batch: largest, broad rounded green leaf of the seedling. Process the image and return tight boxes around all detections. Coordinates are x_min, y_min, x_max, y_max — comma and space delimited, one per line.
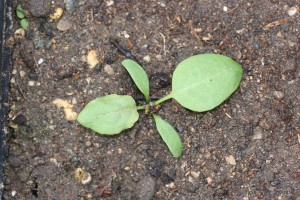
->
170, 54, 243, 112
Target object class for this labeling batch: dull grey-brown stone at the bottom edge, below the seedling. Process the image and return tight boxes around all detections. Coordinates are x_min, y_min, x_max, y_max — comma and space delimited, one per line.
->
137, 176, 156, 200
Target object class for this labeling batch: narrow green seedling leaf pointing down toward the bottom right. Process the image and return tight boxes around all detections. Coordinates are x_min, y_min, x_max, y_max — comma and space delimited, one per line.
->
153, 114, 182, 158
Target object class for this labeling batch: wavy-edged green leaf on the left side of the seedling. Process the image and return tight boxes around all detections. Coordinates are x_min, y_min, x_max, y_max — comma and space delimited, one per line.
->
77, 94, 139, 135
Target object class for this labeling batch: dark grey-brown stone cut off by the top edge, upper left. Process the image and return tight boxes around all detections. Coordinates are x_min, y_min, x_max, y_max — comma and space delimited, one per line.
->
28, 0, 51, 17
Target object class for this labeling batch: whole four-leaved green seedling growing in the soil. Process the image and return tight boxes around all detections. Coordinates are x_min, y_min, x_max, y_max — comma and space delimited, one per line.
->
77, 54, 243, 158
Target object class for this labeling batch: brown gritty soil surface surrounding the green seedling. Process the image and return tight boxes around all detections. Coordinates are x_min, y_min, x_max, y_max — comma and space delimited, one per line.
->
4, 0, 300, 200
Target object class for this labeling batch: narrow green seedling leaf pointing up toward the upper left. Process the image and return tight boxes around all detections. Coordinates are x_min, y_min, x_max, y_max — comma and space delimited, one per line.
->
122, 59, 150, 102
